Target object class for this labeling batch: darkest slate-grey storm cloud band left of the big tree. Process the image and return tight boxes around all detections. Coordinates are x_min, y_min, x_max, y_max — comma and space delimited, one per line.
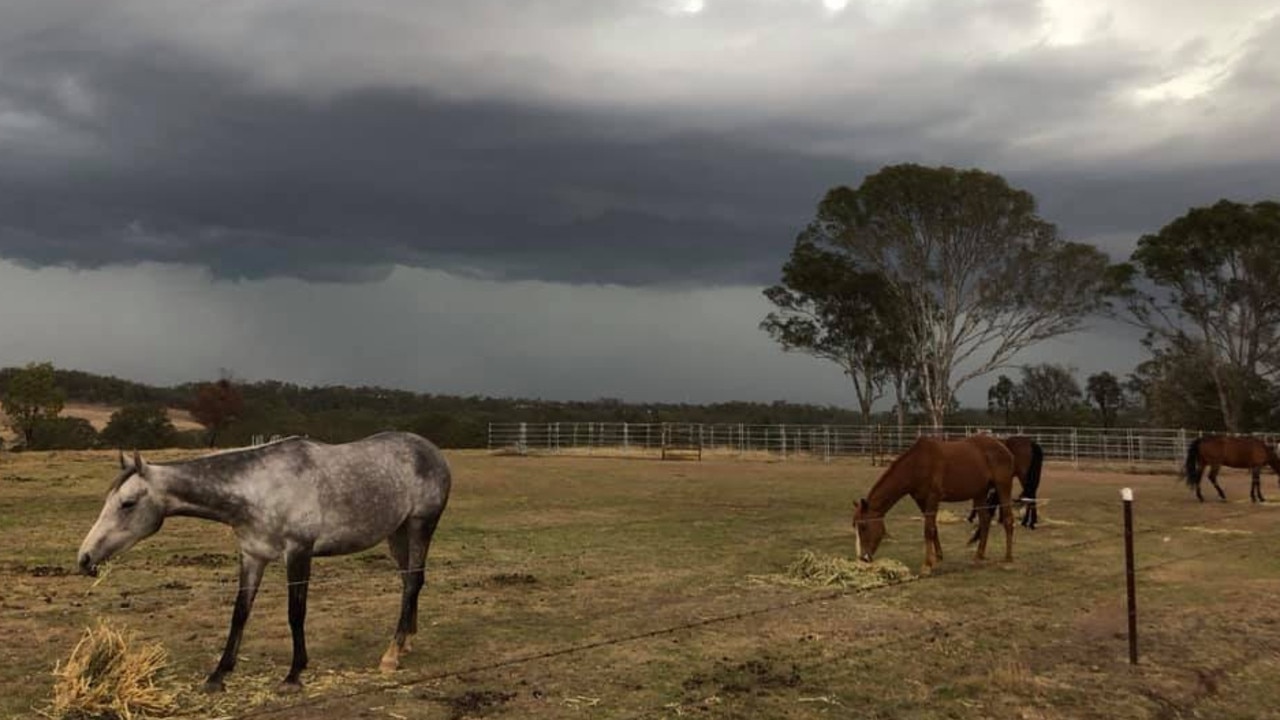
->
0, 43, 852, 284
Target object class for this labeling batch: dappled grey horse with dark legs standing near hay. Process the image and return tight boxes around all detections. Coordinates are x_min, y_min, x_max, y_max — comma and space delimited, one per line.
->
78, 433, 452, 692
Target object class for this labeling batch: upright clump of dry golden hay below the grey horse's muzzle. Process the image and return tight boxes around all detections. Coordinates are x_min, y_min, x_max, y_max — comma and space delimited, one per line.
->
44, 623, 177, 720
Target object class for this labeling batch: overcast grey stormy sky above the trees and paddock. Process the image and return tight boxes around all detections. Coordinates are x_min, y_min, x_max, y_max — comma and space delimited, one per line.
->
0, 0, 1280, 404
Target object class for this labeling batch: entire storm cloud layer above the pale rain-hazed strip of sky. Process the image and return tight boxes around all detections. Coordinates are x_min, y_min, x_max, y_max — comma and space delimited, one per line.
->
0, 1, 1280, 286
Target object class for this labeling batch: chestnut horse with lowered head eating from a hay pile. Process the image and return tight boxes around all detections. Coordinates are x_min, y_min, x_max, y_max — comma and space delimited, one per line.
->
854, 436, 1014, 574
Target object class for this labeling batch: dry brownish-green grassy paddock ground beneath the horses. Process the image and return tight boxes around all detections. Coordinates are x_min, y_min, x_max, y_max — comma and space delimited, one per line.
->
0, 452, 1280, 720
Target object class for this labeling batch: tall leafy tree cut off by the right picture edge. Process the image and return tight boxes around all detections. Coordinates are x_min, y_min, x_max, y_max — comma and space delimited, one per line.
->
1111, 200, 1280, 432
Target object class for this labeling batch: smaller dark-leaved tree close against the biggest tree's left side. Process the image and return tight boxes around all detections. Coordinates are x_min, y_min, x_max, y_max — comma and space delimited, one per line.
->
760, 231, 908, 423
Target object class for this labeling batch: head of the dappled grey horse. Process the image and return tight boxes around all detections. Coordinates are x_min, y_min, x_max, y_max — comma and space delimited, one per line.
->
78, 451, 164, 575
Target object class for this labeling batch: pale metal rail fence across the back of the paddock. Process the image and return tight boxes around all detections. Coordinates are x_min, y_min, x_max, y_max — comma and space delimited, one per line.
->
489, 423, 1280, 469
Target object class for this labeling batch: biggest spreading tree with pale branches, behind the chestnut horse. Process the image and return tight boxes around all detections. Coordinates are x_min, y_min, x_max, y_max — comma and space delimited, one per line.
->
810, 164, 1107, 427
